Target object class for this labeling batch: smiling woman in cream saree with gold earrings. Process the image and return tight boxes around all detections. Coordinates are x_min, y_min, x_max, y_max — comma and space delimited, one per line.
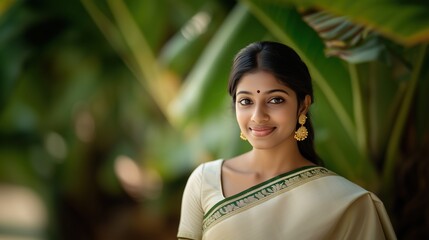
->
178, 42, 396, 240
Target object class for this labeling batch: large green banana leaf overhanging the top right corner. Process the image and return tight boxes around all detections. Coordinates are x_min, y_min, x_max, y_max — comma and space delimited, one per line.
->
269, 0, 429, 46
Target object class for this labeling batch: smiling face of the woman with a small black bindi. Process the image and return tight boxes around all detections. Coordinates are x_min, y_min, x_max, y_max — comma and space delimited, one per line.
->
235, 71, 307, 149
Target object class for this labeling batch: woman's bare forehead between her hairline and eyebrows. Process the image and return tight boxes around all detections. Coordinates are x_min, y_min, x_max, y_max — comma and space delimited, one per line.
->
237, 71, 292, 92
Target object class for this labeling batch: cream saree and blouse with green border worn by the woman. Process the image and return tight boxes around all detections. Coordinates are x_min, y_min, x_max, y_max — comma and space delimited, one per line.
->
178, 160, 396, 240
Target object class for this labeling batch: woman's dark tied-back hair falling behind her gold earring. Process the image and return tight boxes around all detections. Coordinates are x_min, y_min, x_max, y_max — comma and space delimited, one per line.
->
228, 41, 323, 166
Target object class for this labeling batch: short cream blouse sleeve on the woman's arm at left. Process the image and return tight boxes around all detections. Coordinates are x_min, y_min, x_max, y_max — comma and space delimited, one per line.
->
177, 164, 204, 240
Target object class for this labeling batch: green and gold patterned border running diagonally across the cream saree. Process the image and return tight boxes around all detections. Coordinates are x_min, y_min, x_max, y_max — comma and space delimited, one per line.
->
203, 166, 336, 231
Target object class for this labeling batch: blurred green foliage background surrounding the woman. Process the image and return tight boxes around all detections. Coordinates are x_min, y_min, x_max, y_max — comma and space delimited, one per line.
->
0, 0, 429, 239
